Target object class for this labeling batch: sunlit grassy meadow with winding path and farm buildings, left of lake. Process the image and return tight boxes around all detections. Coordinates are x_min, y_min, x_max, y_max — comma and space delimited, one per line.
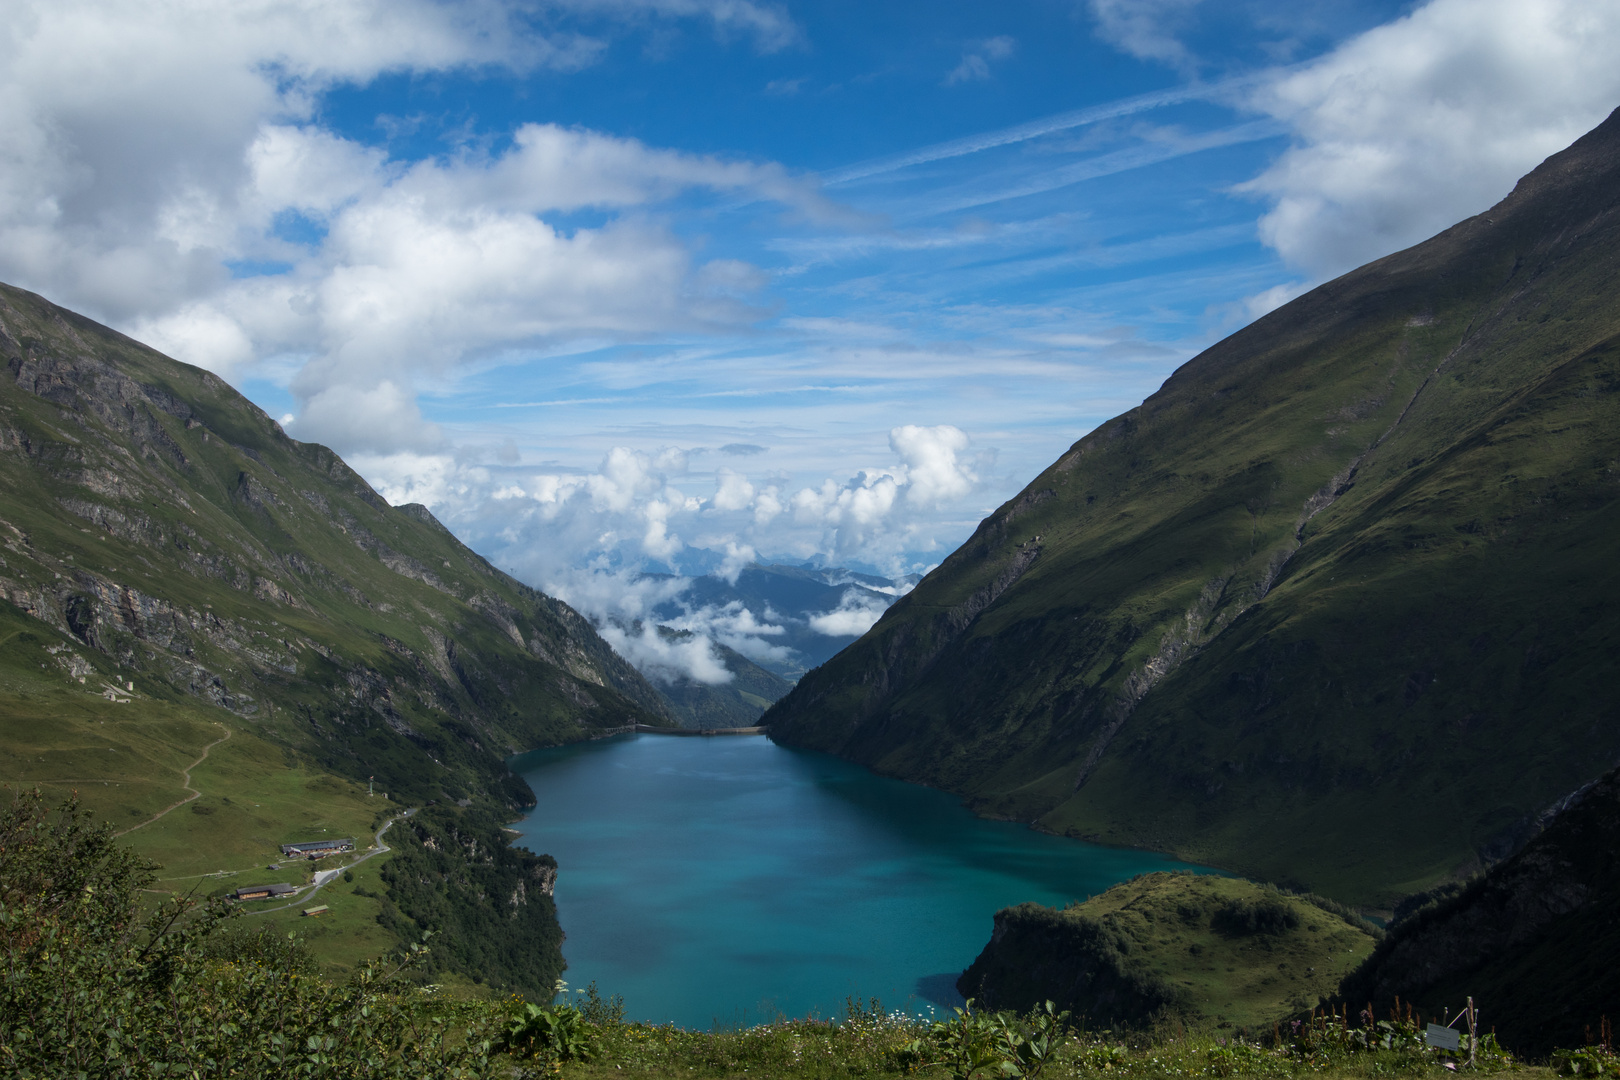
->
0, 612, 411, 975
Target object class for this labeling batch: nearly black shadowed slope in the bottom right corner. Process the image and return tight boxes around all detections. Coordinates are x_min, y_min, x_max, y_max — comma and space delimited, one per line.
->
1340, 771, 1620, 1054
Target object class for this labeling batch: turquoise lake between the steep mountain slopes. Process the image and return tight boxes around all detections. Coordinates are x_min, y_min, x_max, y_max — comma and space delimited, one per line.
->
512, 735, 1211, 1028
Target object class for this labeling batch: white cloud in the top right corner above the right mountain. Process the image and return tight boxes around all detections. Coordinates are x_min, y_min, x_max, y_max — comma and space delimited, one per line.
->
1246, 0, 1620, 277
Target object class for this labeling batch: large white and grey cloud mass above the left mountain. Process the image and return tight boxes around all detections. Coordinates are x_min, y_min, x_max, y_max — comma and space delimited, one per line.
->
0, 0, 838, 453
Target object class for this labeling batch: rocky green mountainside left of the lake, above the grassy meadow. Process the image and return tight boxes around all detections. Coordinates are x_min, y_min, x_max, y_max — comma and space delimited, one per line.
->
0, 287, 666, 806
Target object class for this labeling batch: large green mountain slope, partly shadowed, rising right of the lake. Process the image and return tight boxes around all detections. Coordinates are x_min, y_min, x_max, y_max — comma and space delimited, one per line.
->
765, 117, 1620, 904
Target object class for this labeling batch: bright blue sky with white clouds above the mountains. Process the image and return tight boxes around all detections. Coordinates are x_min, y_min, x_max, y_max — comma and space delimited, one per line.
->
0, 0, 1620, 660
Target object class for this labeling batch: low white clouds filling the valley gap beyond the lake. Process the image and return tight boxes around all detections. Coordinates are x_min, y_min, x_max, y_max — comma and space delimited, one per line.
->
360, 426, 946, 685
